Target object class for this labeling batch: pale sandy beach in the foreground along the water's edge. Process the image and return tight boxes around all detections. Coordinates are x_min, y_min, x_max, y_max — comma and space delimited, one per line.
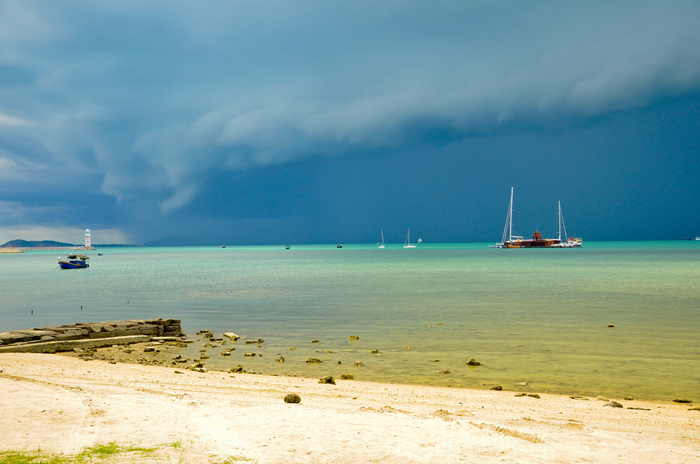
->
0, 353, 700, 463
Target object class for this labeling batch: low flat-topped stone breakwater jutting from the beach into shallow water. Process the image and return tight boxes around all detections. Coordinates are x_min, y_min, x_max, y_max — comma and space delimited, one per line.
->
0, 319, 184, 352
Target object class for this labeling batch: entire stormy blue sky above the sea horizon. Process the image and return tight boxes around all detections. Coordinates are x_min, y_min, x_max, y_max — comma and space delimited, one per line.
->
0, 0, 700, 245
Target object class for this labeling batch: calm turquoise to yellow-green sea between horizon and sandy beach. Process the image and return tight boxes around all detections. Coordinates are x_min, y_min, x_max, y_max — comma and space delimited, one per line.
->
0, 241, 700, 401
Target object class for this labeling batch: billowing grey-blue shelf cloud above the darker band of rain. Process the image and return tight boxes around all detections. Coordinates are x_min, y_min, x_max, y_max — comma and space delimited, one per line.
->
0, 0, 700, 234
